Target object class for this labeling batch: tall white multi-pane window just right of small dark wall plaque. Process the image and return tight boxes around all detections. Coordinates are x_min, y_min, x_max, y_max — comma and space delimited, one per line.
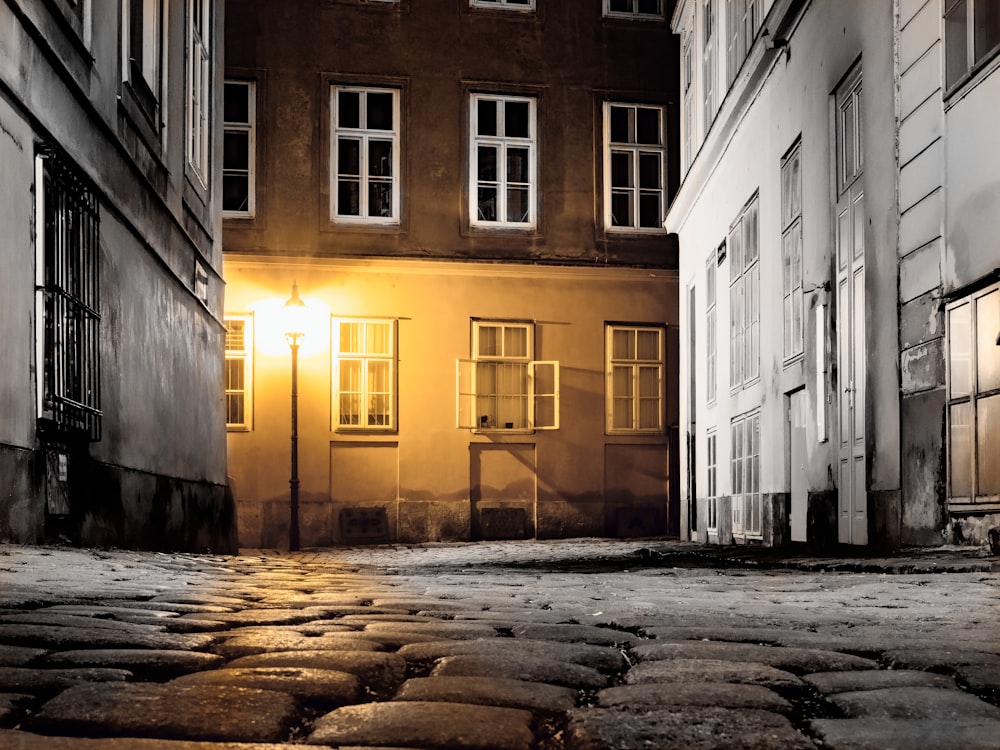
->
727, 195, 760, 388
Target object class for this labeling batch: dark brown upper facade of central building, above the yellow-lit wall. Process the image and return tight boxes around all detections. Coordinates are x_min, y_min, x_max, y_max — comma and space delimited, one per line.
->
224, 0, 679, 268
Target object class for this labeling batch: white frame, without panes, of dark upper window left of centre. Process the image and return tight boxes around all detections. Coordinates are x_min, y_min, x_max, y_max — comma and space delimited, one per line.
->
330, 84, 402, 226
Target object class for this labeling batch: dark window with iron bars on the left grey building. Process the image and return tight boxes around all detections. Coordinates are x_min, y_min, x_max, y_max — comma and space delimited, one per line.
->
35, 146, 102, 441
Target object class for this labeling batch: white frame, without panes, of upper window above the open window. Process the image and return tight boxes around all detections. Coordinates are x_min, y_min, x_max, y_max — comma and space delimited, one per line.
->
469, 93, 538, 229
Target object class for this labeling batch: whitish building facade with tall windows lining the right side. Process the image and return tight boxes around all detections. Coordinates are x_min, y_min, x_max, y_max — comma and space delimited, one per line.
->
665, 0, 1000, 548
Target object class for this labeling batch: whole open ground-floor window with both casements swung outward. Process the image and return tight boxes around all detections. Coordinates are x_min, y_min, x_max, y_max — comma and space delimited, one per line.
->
458, 320, 559, 431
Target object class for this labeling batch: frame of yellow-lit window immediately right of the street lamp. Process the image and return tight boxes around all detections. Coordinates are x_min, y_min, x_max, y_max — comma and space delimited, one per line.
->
332, 318, 397, 432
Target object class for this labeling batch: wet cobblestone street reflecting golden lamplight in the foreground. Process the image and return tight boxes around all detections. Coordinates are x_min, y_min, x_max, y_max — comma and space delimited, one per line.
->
0, 539, 1000, 750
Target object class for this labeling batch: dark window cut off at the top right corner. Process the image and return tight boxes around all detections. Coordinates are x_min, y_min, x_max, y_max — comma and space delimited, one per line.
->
944, 0, 1000, 89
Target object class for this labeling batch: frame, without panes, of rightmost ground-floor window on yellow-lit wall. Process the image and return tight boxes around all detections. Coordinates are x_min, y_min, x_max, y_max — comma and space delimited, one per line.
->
605, 323, 666, 435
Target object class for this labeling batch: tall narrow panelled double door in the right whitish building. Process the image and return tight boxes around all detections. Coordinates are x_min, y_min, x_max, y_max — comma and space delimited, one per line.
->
837, 183, 868, 544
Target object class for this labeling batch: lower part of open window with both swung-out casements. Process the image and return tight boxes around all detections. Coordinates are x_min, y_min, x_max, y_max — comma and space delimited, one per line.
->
455, 359, 559, 432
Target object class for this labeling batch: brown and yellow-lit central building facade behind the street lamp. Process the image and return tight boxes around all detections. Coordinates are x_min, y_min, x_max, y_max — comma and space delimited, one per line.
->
223, 0, 679, 547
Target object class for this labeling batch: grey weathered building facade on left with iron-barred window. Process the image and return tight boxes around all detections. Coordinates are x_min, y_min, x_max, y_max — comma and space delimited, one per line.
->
0, 0, 236, 552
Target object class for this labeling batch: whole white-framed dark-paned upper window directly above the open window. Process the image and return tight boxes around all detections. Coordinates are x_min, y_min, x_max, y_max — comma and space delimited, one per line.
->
469, 94, 538, 228
